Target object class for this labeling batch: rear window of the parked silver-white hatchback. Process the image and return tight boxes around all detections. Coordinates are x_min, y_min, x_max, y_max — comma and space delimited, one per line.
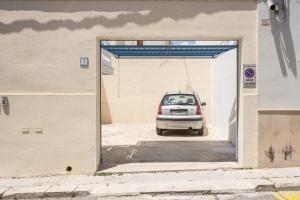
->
162, 94, 197, 106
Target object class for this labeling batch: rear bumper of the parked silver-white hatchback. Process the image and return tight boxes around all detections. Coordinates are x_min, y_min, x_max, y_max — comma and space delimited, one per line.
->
156, 116, 203, 129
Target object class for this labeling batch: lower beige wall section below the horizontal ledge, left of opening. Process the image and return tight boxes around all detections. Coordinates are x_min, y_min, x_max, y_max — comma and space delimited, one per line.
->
0, 94, 96, 176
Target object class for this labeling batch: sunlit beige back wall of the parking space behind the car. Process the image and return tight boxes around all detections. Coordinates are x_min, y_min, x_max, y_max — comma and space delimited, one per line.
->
101, 59, 211, 125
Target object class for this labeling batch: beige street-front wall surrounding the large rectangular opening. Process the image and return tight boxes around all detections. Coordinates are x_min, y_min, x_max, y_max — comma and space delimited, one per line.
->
0, 0, 257, 176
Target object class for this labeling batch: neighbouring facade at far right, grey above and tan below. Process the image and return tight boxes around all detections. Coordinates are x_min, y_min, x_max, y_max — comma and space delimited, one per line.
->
258, 0, 300, 167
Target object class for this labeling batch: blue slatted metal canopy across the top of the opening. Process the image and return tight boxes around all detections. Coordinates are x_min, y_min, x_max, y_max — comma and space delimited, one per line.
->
101, 44, 237, 58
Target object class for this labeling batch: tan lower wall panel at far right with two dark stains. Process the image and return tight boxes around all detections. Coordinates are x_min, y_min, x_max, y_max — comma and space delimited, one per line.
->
258, 110, 300, 167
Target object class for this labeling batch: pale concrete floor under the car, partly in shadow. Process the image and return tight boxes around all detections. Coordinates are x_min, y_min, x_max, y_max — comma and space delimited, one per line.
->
101, 124, 240, 172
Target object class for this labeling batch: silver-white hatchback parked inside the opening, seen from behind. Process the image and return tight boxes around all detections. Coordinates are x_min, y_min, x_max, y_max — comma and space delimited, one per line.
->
156, 92, 206, 135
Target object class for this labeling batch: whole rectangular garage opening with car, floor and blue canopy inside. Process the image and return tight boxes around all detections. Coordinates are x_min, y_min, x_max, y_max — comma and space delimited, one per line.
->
100, 40, 239, 172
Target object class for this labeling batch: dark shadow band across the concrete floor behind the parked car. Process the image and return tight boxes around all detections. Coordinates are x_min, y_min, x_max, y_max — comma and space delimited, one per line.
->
101, 141, 236, 170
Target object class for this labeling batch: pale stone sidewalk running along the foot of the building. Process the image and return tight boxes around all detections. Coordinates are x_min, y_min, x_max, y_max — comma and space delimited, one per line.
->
0, 168, 300, 199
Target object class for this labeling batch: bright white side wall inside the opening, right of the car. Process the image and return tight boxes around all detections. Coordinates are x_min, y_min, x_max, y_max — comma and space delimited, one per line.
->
210, 49, 238, 144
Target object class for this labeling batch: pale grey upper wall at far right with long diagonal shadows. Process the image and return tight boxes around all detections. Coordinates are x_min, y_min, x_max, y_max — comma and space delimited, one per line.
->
259, 0, 300, 109
